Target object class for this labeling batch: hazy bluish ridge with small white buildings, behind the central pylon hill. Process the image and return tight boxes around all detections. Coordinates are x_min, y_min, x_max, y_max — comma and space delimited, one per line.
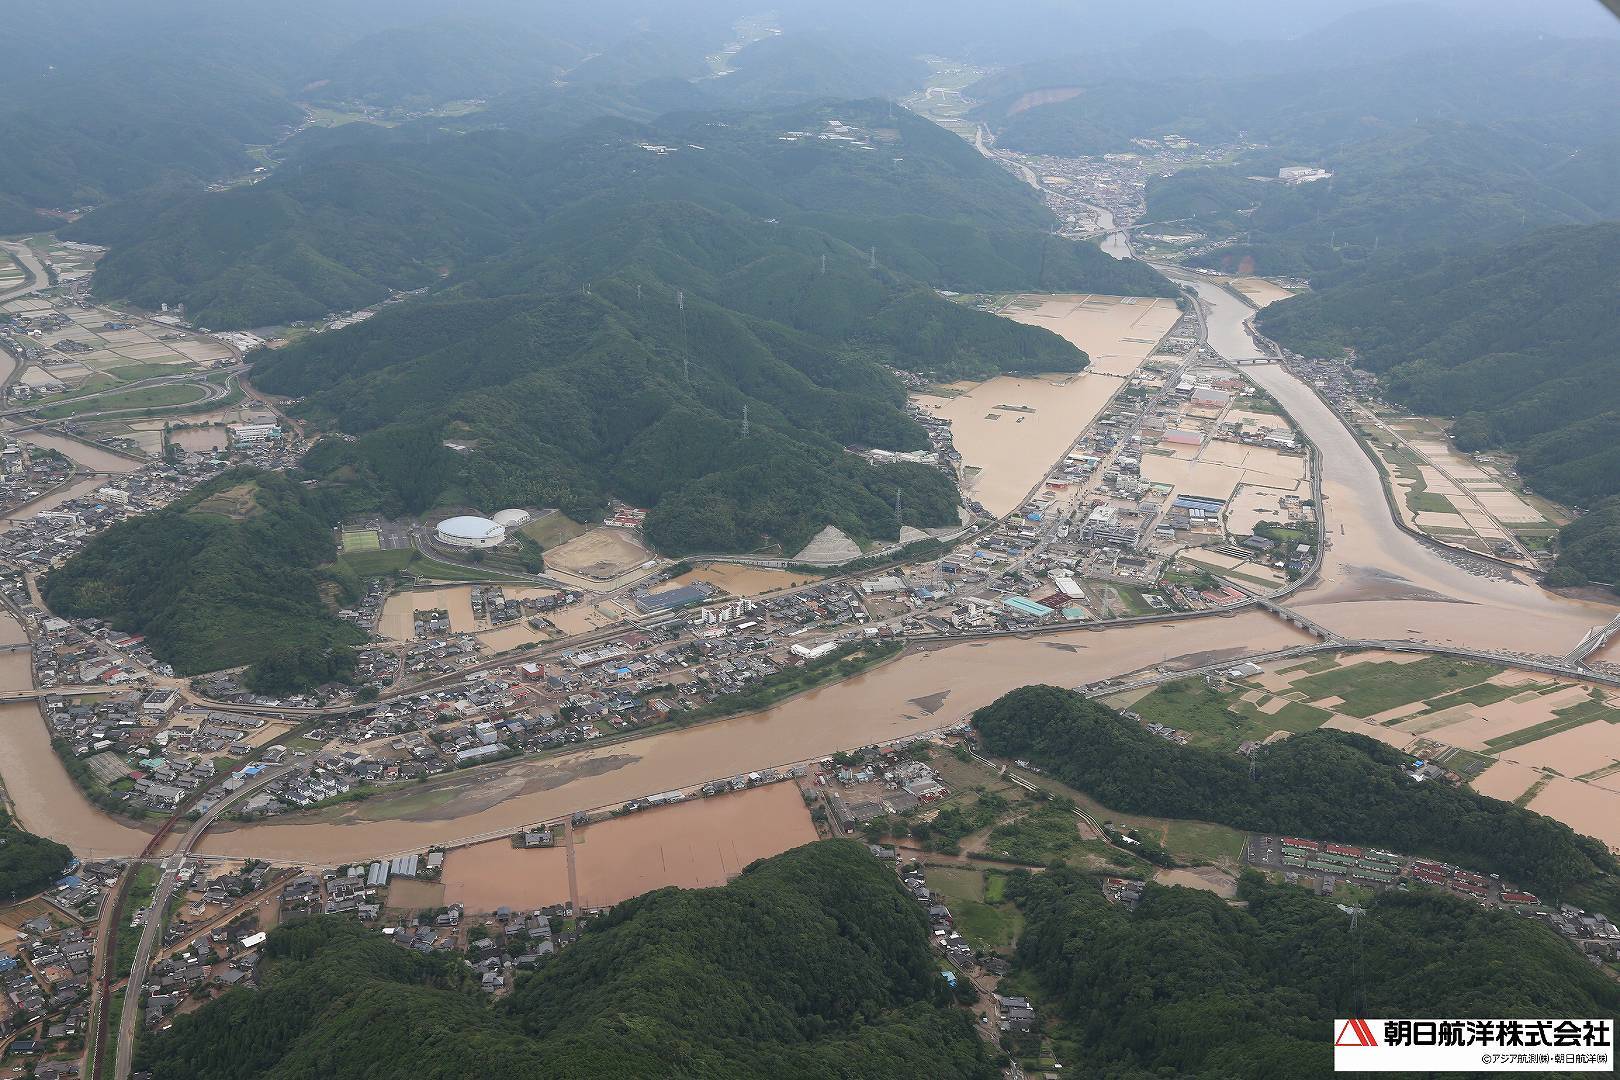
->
66, 100, 1171, 327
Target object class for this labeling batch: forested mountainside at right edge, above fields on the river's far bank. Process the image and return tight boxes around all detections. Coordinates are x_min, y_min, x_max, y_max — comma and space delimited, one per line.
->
1259, 222, 1620, 583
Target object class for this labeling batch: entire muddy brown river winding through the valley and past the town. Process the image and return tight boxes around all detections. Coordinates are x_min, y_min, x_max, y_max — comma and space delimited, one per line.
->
0, 283, 1614, 865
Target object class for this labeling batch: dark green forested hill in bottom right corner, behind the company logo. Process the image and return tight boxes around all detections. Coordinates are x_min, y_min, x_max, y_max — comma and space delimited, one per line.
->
1008, 866, 1620, 1080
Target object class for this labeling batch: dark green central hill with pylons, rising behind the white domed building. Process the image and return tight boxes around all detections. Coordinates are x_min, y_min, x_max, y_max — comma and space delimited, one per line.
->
256, 256, 1004, 554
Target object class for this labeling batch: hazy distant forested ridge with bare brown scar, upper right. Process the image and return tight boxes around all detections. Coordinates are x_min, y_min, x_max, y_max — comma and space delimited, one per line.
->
966, 35, 1620, 155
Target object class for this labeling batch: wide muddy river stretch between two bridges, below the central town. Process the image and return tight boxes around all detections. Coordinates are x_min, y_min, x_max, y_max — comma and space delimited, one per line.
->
203, 612, 1309, 863
